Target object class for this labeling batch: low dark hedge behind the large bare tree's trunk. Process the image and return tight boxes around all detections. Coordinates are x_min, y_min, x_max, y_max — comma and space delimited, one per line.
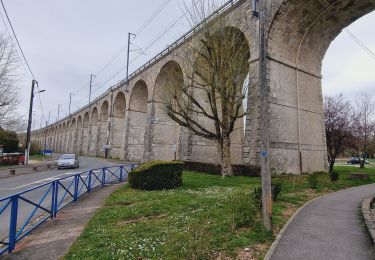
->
183, 161, 260, 177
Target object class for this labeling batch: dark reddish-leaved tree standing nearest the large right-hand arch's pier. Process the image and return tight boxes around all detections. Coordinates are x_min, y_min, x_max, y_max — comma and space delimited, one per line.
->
324, 94, 354, 173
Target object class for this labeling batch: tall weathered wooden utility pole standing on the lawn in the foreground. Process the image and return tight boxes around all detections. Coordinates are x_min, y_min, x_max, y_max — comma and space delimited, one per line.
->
258, 0, 272, 231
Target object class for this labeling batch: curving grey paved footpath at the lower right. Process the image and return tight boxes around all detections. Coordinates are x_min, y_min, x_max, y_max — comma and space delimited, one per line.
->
271, 184, 375, 260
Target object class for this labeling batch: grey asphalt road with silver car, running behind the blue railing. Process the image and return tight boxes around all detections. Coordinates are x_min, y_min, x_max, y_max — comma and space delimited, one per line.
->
0, 157, 122, 246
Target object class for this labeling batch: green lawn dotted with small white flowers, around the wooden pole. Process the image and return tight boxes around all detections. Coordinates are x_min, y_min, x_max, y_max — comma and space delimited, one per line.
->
65, 166, 375, 259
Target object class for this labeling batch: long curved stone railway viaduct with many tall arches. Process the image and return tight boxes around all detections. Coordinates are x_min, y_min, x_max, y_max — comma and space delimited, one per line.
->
32, 0, 375, 173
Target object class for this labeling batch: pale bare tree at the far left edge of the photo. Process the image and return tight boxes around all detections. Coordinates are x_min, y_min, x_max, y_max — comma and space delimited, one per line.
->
0, 35, 19, 129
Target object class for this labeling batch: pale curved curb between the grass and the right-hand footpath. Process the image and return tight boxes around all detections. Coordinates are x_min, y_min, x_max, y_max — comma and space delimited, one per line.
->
264, 183, 375, 260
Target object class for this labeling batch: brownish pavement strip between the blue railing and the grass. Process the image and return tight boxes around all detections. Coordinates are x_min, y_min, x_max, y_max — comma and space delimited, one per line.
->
0, 184, 121, 260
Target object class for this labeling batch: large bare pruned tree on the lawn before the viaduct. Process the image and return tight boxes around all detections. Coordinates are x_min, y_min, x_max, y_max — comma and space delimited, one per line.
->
164, 1, 250, 176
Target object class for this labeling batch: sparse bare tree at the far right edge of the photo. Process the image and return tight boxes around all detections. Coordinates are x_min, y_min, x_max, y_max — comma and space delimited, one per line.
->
353, 92, 375, 168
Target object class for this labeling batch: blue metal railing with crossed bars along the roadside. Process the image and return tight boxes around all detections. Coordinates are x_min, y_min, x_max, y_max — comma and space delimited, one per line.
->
0, 164, 138, 255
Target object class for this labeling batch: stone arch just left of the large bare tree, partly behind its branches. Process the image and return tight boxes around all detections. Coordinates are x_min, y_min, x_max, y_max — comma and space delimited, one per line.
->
150, 60, 184, 160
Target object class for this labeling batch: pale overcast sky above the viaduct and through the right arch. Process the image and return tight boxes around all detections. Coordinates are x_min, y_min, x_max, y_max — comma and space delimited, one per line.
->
0, 0, 375, 130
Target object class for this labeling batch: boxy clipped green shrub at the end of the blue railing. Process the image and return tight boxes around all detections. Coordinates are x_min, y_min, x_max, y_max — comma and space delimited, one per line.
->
129, 161, 182, 190
